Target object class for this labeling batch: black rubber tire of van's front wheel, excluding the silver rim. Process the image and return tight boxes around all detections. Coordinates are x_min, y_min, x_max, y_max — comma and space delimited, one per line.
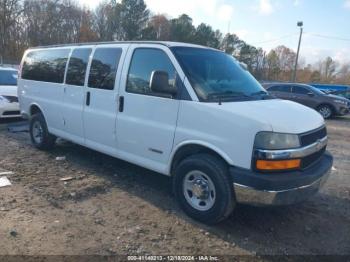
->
173, 154, 236, 224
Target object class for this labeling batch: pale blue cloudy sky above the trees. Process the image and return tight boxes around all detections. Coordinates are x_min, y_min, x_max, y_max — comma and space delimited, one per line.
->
79, 0, 350, 63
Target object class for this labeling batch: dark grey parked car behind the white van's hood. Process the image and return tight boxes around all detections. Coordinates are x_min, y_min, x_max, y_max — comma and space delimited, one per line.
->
263, 83, 350, 119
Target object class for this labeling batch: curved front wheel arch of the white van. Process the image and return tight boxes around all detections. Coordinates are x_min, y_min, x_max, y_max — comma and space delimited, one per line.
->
168, 141, 233, 176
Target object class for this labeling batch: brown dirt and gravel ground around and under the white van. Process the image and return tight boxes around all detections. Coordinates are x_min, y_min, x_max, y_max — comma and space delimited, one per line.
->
0, 117, 350, 255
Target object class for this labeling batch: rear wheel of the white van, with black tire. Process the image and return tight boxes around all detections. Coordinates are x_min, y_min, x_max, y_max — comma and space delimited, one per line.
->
29, 113, 56, 150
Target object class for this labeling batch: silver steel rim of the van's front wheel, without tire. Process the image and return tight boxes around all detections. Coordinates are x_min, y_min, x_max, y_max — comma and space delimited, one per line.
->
183, 170, 216, 211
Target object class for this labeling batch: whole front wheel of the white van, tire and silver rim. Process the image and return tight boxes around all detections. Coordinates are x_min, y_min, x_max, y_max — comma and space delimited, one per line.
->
174, 154, 236, 224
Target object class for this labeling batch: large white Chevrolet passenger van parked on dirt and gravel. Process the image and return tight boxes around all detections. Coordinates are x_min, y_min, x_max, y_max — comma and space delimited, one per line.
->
18, 42, 333, 224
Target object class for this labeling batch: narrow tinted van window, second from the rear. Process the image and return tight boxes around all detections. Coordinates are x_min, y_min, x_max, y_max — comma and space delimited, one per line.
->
66, 48, 91, 86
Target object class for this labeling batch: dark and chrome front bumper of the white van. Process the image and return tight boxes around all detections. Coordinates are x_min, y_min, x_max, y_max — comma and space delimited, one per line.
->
230, 152, 333, 206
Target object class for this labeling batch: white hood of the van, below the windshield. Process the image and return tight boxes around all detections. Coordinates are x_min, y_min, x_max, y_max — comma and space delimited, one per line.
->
209, 99, 324, 134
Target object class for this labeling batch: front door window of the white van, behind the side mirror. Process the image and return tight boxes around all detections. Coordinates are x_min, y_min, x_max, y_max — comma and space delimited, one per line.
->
126, 48, 176, 95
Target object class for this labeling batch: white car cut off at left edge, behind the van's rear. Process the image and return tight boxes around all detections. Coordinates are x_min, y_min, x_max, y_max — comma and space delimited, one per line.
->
0, 67, 21, 118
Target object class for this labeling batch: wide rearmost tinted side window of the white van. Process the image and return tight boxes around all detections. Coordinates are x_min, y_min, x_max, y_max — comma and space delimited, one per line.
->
22, 49, 70, 83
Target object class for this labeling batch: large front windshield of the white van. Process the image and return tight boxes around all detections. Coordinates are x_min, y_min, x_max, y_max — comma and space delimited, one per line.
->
171, 47, 272, 102
